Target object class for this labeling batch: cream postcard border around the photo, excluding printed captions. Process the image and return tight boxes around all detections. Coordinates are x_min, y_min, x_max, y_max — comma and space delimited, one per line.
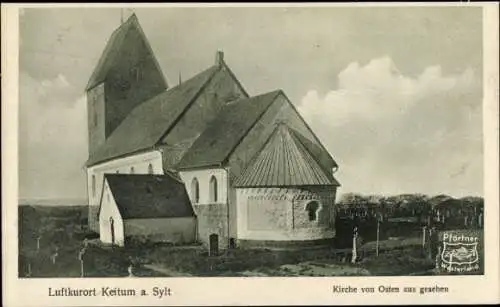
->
1, 3, 500, 307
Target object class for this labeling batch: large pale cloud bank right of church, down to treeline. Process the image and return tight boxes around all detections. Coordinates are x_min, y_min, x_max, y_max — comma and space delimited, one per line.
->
299, 57, 482, 199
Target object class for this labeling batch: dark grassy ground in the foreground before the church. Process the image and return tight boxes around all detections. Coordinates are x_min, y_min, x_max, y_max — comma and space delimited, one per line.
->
19, 206, 483, 277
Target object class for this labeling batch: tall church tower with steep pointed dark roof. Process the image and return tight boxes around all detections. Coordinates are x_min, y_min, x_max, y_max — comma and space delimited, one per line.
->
85, 14, 168, 157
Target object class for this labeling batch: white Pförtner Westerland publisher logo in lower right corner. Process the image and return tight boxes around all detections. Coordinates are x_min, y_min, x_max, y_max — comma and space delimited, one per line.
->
441, 233, 479, 272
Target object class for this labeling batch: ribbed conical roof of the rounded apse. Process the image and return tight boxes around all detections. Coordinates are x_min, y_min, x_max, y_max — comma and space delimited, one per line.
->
235, 123, 339, 187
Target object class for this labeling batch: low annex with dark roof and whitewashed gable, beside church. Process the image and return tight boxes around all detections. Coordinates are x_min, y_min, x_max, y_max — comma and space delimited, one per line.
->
99, 174, 196, 246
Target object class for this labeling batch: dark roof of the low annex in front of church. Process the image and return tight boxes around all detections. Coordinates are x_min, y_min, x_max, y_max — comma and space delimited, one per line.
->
104, 174, 195, 219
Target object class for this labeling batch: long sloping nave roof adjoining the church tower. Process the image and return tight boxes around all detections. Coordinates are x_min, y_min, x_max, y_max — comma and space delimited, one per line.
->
87, 65, 220, 166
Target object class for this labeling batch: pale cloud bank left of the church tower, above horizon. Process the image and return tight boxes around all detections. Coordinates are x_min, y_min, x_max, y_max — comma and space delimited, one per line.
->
19, 72, 87, 198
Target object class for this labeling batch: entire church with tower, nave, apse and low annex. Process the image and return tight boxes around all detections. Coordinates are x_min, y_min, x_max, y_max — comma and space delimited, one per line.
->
86, 14, 339, 248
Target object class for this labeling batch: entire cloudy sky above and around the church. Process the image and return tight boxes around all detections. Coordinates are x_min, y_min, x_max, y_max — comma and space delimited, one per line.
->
19, 7, 483, 198
